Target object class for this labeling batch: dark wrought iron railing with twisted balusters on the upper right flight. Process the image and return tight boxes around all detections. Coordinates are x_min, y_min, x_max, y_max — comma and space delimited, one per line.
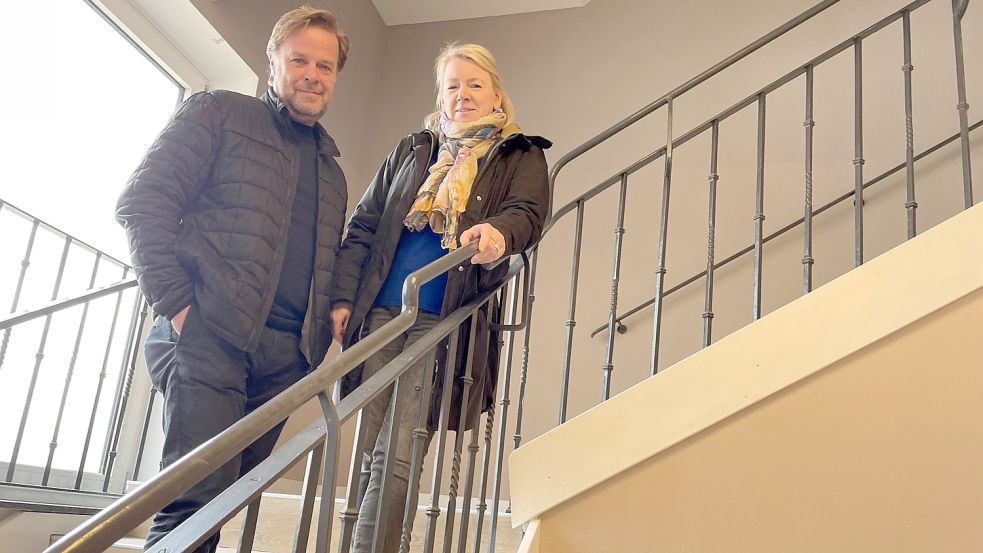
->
533, 0, 980, 423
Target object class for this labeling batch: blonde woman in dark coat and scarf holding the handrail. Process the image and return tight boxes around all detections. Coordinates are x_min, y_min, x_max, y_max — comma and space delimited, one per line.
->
332, 44, 551, 552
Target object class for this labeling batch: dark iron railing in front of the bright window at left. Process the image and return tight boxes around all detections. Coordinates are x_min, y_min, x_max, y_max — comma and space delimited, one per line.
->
0, 200, 141, 502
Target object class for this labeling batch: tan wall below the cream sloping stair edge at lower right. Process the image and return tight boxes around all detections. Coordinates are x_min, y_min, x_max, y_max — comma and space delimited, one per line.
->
540, 293, 983, 553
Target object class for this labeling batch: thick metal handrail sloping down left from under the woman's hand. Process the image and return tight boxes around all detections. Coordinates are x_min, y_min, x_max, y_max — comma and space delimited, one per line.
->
45, 242, 492, 553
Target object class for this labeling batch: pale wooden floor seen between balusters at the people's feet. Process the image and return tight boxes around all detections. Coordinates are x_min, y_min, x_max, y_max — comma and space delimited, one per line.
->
214, 496, 522, 553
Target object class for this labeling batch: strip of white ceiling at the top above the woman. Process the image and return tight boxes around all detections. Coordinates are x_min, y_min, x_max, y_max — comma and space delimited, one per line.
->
372, 0, 590, 25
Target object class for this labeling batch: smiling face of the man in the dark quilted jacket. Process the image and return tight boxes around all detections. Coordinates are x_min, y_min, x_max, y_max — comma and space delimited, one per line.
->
270, 27, 338, 125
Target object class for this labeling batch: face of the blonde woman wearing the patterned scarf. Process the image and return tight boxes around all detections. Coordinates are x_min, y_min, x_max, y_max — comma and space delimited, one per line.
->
440, 58, 502, 123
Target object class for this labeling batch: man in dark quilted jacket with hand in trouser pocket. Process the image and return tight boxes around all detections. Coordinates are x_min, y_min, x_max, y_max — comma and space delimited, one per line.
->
117, 7, 348, 552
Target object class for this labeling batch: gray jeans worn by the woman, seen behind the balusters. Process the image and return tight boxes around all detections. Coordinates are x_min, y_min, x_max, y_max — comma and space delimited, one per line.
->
352, 307, 440, 553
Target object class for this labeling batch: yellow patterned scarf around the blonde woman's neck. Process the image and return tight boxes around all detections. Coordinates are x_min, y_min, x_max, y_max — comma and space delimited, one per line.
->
403, 112, 505, 250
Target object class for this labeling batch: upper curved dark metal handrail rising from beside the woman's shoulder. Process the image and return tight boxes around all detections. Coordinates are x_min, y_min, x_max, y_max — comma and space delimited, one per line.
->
549, 0, 840, 213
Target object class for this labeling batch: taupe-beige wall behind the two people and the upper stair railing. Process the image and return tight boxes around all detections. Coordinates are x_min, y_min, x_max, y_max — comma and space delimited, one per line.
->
181, 0, 983, 494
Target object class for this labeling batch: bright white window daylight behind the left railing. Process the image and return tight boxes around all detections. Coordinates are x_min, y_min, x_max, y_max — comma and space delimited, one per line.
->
0, 0, 184, 474
